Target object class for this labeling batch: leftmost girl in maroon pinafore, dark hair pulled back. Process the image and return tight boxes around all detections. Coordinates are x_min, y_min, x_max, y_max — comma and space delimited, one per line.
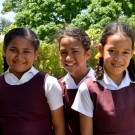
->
0, 28, 65, 135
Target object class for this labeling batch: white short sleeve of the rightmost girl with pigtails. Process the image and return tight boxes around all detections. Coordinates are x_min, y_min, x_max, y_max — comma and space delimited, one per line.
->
71, 82, 94, 117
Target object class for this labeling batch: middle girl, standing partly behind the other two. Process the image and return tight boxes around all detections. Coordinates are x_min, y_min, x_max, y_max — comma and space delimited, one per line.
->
58, 28, 94, 135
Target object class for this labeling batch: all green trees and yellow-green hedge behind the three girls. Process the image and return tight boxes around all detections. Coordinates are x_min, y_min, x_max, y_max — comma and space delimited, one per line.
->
0, 0, 135, 78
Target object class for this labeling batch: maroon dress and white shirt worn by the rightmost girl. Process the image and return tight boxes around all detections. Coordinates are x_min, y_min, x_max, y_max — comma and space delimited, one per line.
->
72, 70, 135, 135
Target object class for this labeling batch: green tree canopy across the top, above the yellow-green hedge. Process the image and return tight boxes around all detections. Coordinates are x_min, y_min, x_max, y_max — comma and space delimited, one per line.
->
2, 0, 135, 42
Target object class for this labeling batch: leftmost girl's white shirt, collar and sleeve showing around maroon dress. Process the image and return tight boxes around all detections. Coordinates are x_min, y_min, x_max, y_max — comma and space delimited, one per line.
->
4, 66, 63, 111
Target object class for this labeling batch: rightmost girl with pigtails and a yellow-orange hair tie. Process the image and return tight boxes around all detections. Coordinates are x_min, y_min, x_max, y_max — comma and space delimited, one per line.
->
72, 22, 135, 135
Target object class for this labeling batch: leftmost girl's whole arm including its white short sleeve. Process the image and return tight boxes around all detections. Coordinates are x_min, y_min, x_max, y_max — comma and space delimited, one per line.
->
45, 76, 65, 135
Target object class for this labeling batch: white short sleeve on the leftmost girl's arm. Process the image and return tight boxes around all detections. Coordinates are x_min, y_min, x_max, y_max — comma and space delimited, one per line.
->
44, 76, 63, 111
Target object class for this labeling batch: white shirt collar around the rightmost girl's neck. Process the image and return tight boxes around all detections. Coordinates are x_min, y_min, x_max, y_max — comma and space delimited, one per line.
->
93, 69, 135, 90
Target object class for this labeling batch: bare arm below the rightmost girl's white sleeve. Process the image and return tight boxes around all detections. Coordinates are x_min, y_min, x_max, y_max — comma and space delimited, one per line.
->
79, 113, 93, 135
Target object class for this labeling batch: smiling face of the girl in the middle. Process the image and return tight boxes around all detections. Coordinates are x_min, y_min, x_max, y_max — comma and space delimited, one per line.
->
59, 36, 91, 77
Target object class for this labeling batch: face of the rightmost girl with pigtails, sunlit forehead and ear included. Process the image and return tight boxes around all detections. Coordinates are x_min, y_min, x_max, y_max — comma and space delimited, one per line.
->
99, 33, 133, 79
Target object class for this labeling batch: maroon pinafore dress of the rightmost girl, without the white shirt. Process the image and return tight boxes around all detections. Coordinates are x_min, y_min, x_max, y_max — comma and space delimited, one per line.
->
84, 78, 135, 135
